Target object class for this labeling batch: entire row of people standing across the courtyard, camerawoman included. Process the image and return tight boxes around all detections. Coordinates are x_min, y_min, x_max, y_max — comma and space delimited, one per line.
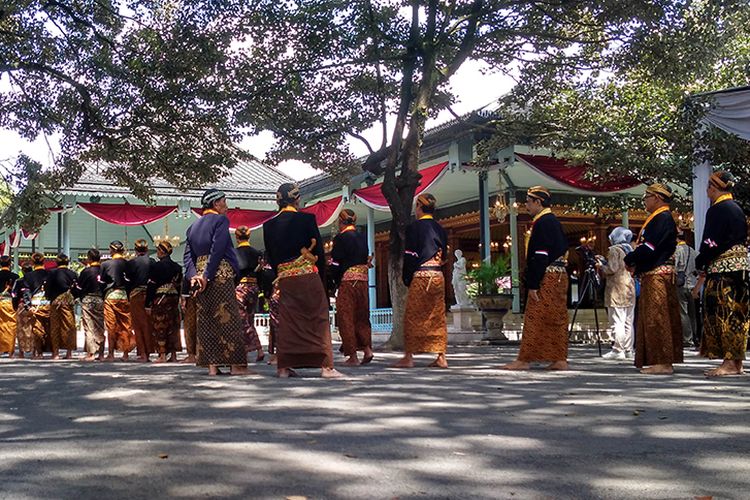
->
0, 172, 750, 378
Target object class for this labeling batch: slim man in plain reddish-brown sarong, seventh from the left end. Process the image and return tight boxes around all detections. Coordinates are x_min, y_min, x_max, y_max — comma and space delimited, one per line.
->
125, 238, 156, 363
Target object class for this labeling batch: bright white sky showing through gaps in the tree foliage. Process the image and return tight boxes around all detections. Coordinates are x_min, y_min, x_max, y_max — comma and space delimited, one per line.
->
0, 61, 514, 180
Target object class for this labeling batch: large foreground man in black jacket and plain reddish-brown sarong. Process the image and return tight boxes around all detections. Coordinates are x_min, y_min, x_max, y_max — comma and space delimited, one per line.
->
263, 183, 341, 378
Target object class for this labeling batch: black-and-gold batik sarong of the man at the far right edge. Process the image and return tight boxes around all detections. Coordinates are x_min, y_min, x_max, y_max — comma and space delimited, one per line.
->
701, 271, 750, 360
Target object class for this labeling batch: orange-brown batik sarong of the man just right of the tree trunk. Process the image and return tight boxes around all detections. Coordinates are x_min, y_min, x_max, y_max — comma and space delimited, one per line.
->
404, 271, 448, 354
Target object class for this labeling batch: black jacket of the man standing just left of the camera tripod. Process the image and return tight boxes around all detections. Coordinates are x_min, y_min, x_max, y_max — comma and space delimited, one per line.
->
526, 213, 568, 290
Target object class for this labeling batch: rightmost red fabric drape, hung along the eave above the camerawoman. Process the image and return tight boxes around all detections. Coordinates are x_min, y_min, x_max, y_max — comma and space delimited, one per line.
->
516, 153, 641, 193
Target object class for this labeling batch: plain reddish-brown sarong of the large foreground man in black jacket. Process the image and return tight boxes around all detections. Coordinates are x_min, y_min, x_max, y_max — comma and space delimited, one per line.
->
276, 257, 333, 369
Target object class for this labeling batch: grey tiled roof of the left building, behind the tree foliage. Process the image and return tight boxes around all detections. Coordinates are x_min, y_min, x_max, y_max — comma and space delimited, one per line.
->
61, 160, 293, 201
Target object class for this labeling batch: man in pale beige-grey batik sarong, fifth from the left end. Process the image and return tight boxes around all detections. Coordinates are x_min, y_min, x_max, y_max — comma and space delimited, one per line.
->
72, 248, 106, 361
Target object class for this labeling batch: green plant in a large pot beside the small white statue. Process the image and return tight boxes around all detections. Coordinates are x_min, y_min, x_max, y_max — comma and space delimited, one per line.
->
466, 255, 513, 340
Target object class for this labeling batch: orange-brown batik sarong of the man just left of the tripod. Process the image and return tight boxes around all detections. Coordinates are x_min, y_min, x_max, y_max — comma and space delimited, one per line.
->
518, 270, 568, 363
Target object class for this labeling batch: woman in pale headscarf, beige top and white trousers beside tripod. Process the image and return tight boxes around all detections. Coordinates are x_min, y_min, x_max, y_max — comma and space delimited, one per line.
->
597, 227, 635, 359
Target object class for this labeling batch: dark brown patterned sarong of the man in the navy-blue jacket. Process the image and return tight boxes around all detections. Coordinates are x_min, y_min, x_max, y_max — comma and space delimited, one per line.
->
196, 256, 247, 366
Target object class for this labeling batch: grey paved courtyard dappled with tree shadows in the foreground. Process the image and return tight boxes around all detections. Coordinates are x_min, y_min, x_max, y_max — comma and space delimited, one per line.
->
0, 347, 750, 499
